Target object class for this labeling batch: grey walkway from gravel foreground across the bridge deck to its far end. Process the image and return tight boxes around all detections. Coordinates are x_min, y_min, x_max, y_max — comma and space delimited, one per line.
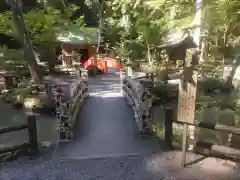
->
0, 75, 240, 180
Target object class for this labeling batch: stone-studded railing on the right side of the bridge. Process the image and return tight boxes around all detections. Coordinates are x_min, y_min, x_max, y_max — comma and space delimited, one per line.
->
121, 72, 153, 134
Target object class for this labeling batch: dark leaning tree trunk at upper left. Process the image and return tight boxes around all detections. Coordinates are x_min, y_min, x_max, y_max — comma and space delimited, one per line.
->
7, 0, 42, 84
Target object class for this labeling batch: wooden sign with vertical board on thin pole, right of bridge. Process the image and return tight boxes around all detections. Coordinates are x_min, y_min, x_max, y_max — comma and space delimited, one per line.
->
177, 66, 197, 167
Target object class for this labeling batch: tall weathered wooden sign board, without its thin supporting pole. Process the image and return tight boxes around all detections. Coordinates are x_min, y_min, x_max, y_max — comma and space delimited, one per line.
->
177, 67, 197, 123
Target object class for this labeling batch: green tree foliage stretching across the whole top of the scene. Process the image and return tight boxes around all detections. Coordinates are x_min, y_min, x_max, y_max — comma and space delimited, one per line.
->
0, 0, 240, 81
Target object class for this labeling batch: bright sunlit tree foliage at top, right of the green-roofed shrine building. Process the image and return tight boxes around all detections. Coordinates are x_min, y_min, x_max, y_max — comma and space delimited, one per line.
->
85, 0, 240, 74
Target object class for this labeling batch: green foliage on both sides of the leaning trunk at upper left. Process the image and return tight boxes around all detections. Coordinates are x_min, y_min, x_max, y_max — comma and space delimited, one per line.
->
0, 1, 85, 49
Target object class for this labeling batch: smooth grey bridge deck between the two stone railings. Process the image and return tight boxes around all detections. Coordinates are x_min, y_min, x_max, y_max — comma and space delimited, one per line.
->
56, 74, 159, 159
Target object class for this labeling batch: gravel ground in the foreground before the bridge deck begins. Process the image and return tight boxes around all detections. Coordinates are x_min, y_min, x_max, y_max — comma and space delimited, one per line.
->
0, 152, 240, 180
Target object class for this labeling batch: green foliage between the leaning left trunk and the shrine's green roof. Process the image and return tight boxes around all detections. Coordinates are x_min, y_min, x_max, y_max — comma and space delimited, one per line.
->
24, 5, 85, 49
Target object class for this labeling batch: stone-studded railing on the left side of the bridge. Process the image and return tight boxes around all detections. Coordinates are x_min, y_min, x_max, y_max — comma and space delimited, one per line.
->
49, 78, 88, 141
